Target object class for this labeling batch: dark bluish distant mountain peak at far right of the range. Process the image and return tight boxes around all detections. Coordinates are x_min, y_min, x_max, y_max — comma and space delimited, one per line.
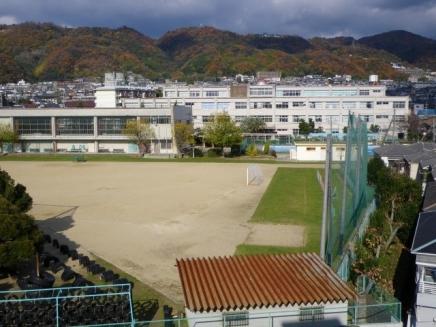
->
358, 30, 436, 69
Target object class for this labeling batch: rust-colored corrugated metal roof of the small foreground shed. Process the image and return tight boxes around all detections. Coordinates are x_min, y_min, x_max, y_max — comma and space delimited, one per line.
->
177, 253, 356, 311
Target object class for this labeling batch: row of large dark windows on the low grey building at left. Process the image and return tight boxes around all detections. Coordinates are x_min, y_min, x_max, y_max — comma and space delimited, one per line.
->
14, 116, 171, 135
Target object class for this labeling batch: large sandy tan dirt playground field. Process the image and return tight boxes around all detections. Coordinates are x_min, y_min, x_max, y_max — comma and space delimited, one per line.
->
1, 162, 320, 302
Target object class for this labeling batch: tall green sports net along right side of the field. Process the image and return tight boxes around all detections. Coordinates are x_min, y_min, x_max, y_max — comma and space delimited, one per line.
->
325, 115, 373, 279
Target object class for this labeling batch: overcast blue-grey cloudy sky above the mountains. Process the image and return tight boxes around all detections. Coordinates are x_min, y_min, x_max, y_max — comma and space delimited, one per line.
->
0, 0, 436, 39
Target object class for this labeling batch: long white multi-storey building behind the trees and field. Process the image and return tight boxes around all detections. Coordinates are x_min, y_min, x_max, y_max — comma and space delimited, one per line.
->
95, 83, 409, 135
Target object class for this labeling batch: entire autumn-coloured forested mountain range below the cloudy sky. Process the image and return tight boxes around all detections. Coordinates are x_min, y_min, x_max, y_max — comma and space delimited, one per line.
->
0, 23, 436, 83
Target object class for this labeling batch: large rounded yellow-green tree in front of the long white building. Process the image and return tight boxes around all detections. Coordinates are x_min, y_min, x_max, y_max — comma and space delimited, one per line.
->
204, 113, 242, 155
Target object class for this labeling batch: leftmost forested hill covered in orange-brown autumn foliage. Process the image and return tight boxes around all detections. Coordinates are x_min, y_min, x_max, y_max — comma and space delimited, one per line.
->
0, 23, 167, 82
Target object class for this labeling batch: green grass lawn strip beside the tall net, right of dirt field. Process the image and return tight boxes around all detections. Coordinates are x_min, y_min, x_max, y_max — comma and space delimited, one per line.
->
236, 167, 323, 254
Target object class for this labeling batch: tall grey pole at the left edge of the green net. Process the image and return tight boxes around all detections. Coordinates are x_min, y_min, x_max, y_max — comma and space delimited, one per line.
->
319, 135, 332, 261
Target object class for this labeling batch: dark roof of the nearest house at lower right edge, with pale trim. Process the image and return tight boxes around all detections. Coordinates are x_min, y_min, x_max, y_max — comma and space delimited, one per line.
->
411, 211, 436, 254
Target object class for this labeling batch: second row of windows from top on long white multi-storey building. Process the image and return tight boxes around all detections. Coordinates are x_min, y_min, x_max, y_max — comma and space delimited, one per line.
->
196, 101, 406, 110
